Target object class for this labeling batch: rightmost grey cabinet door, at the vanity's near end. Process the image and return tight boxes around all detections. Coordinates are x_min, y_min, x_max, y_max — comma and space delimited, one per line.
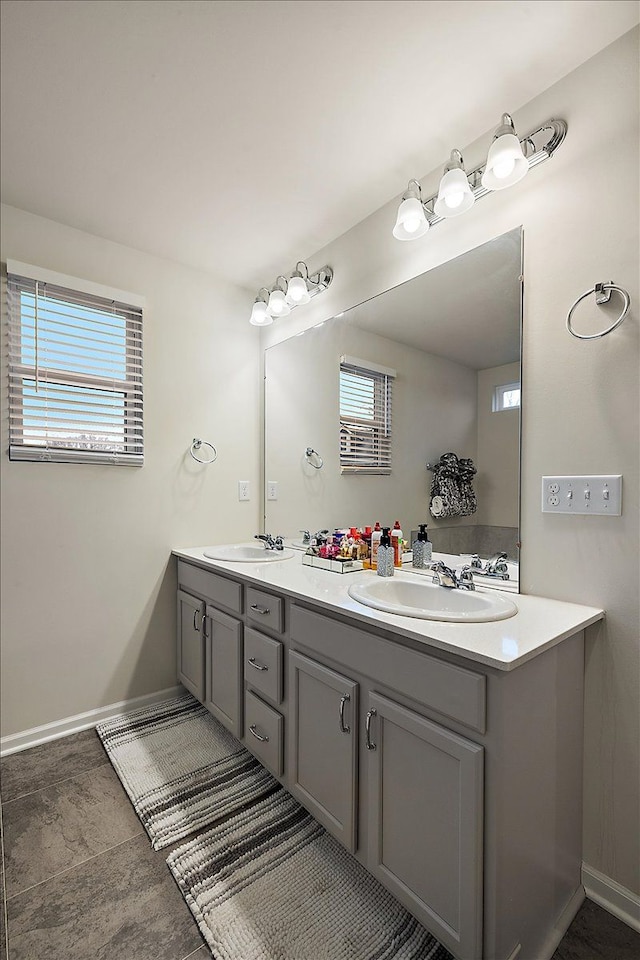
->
367, 693, 484, 960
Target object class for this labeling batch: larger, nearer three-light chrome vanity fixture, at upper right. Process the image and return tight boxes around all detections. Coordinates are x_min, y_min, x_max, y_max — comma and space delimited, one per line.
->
393, 113, 567, 240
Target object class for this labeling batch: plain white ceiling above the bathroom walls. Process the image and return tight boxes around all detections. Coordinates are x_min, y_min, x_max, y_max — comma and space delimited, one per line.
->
1, 0, 639, 288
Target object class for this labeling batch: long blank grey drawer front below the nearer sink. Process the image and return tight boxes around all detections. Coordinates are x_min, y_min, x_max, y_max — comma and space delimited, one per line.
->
291, 604, 486, 733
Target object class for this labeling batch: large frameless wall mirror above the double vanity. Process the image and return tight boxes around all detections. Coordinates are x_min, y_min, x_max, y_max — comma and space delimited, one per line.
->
265, 228, 522, 584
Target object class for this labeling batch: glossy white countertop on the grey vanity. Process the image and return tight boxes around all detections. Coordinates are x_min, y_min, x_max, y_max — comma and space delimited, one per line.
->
173, 547, 604, 670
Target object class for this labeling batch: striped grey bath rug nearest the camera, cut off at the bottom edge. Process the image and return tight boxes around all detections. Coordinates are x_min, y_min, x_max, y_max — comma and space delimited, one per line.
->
167, 784, 453, 960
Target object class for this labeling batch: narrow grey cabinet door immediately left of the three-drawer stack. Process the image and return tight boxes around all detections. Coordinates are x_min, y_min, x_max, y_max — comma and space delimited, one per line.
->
204, 604, 243, 739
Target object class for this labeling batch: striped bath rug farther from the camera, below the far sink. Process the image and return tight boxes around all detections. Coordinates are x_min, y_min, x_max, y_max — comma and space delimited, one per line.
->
96, 694, 277, 850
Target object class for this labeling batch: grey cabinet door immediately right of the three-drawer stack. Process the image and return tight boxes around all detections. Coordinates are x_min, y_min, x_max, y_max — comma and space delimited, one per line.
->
289, 651, 358, 852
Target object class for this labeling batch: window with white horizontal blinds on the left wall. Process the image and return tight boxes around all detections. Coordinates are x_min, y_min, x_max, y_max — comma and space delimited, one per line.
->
7, 261, 143, 466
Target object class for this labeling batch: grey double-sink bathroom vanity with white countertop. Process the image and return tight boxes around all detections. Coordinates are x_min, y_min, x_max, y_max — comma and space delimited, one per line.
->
174, 548, 603, 960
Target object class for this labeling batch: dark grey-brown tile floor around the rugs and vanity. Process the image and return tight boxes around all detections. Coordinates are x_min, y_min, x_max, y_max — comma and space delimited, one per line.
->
0, 730, 640, 960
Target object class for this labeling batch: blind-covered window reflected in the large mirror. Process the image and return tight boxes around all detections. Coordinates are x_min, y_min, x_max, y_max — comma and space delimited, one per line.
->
340, 357, 396, 474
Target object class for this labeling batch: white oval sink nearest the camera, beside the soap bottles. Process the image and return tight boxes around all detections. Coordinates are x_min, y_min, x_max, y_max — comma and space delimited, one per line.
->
348, 576, 518, 623
